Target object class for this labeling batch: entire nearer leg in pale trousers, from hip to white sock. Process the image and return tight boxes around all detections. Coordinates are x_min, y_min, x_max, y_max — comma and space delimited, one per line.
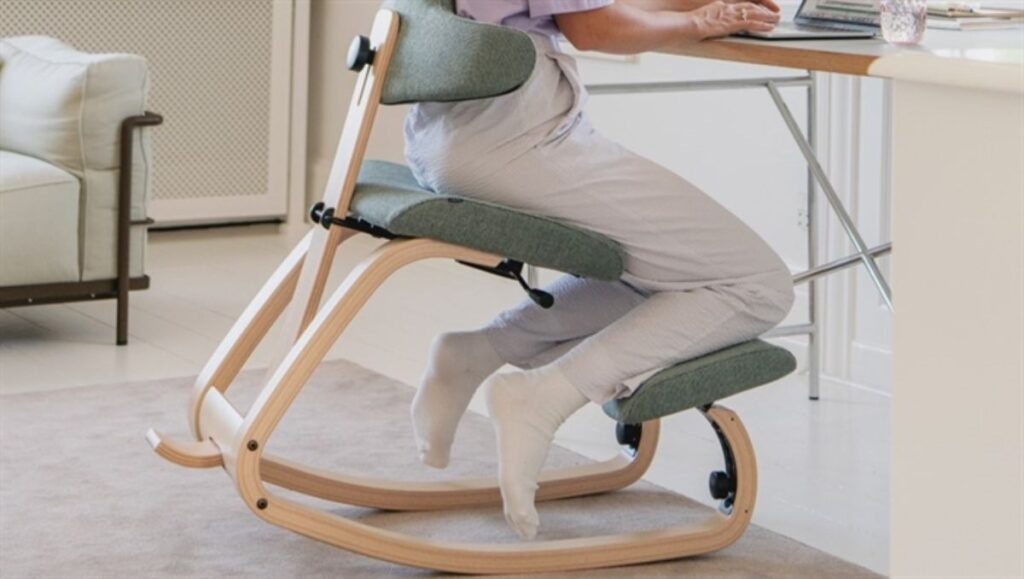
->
413, 106, 793, 536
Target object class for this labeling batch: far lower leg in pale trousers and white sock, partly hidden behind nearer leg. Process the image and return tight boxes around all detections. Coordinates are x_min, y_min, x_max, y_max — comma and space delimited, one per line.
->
412, 276, 645, 468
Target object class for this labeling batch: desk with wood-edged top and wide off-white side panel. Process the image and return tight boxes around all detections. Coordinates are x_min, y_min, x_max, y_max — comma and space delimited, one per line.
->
664, 29, 1024, 577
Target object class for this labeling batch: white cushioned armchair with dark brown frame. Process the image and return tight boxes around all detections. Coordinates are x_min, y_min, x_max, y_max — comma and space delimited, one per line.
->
0, 37, 162, 344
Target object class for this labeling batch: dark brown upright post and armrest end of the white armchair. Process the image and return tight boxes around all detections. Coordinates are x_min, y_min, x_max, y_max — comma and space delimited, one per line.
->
117, 112, 164, 345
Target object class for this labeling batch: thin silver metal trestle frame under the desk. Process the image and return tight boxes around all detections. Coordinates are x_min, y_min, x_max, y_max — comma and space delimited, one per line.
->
587, 71, 893, 400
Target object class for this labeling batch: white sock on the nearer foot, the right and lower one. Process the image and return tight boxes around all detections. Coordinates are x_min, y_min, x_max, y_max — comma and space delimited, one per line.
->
484, 366, 587, 539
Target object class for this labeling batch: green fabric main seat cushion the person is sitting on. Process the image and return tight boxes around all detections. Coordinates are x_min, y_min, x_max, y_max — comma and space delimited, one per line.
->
349, 161, 626, 281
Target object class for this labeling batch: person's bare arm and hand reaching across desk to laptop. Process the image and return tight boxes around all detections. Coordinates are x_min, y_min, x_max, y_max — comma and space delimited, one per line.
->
555, 0, 778, 54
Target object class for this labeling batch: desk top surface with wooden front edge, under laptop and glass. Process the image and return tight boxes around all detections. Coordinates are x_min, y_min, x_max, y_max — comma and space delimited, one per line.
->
662, 16, 1024, 93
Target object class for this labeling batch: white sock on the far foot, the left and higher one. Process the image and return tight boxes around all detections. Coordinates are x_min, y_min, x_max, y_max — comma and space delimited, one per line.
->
412, 332, 505, 468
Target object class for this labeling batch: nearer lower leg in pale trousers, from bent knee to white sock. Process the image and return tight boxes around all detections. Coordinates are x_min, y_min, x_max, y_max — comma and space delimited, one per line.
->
484, 274, 792, 538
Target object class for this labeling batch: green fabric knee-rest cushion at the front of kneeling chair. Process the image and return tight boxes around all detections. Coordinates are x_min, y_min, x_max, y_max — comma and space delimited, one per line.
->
604, 340, 797, 424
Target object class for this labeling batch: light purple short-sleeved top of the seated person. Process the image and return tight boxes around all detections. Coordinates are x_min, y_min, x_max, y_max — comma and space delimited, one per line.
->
456, 0, 615, 36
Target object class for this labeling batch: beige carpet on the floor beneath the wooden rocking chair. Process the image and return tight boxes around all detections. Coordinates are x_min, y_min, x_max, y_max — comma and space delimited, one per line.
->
0, 362, 877, 579
